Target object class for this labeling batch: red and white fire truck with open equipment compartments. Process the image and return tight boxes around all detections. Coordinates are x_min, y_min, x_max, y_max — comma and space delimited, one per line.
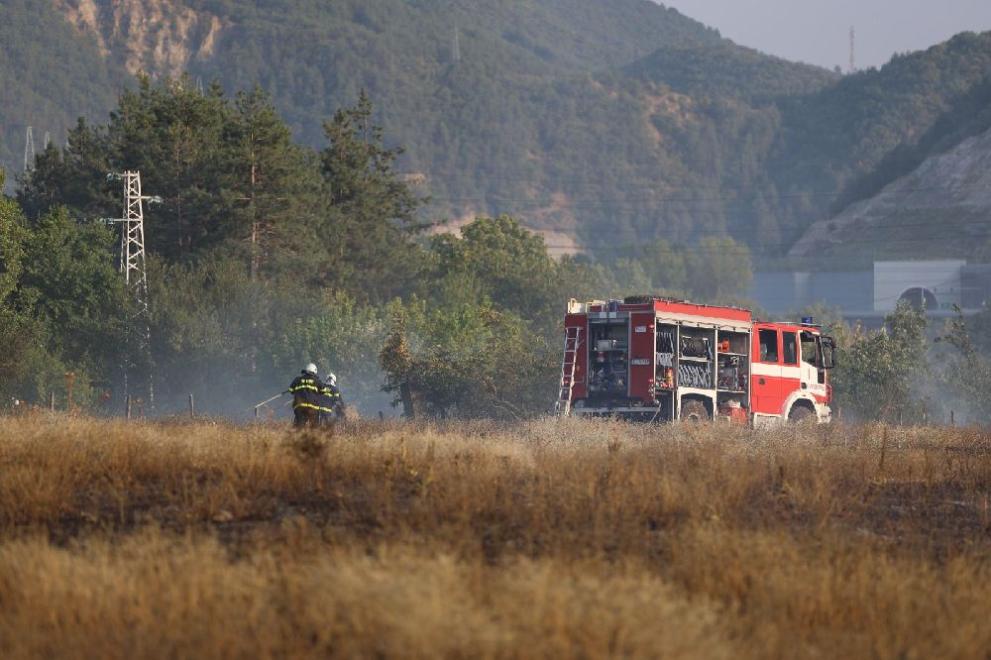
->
556, 296, 834, 425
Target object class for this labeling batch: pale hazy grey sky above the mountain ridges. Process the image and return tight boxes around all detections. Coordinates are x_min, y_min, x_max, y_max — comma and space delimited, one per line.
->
661, 0, 991, 70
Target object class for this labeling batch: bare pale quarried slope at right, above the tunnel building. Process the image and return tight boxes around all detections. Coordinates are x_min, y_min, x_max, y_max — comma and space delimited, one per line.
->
789, 126, 991, 257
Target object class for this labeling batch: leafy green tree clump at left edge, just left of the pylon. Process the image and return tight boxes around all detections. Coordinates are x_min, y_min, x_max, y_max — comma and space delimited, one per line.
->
0, 173, 126, 400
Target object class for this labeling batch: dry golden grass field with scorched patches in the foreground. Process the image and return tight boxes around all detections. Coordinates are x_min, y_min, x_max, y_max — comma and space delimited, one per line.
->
0, 417, 991, 658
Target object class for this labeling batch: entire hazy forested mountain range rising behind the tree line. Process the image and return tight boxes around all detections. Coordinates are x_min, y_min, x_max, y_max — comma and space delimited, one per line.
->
0, 0, 991, 259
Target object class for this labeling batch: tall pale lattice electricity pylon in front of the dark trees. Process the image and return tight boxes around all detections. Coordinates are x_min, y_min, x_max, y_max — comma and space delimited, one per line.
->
109, 171, 161, 406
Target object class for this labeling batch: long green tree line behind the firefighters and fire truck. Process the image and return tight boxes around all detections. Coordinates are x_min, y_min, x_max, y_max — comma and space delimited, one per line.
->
0, 78, 750, 416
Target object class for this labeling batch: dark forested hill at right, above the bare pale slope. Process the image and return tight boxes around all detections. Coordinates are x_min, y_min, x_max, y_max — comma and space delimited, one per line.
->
768, 33, 991, 250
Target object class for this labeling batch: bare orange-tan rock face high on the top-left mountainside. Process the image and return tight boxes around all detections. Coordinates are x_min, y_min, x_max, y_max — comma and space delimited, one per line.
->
55, 0, 227, 76
